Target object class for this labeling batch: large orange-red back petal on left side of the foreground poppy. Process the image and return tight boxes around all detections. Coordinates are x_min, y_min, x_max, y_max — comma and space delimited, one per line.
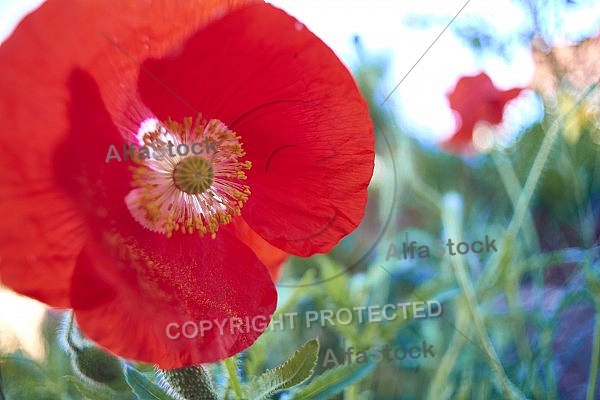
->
0, 0, 252, 306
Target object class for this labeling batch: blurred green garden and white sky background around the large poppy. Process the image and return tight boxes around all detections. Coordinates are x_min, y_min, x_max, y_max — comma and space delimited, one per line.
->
0, 0, 600, 400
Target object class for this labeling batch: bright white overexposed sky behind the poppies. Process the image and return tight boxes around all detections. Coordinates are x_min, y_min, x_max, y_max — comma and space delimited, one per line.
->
0, 0, 600, 141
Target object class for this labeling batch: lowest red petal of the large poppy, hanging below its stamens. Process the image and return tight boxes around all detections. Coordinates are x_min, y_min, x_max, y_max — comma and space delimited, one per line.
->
72, 228, 277, 369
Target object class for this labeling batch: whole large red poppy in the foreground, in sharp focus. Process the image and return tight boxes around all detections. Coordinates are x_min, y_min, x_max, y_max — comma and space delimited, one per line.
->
0, 0, 374, 368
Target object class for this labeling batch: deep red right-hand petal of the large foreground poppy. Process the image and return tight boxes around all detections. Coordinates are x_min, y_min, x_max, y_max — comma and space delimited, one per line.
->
139, 5, 374, 256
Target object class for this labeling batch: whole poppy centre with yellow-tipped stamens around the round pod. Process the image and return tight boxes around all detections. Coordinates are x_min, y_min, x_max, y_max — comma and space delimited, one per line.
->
125, 116, 252, 238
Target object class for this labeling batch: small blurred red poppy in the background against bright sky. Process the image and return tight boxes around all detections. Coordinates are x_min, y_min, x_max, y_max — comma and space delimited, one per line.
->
442, 72, 523, 154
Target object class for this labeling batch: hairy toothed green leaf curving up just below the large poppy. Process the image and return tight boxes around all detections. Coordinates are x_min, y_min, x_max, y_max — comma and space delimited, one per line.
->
245, 339, 319, 399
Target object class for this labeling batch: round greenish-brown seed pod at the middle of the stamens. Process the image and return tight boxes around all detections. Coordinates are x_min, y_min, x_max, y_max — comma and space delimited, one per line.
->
173, 156, 215, 194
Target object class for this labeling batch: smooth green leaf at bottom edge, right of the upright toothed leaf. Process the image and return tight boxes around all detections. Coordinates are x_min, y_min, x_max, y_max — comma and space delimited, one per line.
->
292, 363, 375, 400
